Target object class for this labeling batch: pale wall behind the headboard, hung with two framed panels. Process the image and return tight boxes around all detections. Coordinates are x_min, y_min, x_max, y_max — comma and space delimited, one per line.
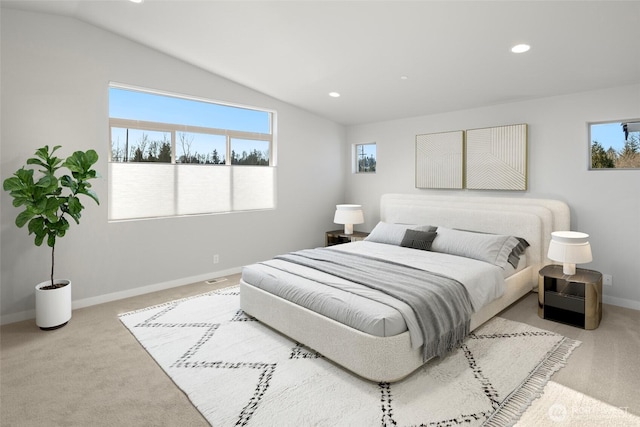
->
345, 85, 640, 310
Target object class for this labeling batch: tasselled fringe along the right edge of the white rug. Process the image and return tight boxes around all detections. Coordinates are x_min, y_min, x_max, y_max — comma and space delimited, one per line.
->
482, 337, 582, 427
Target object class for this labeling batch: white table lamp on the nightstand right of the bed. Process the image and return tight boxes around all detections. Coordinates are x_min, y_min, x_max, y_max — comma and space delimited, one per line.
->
547, 231, 593, 275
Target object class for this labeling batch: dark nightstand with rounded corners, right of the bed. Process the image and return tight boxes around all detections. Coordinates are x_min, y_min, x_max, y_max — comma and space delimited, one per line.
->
538, 265, 602, 329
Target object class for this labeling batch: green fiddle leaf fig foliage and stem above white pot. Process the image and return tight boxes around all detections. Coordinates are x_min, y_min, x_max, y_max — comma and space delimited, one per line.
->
3, 145, 100, 288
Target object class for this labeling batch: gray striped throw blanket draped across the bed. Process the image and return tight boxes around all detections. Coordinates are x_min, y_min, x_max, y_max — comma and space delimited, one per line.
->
275, 248, 473, 361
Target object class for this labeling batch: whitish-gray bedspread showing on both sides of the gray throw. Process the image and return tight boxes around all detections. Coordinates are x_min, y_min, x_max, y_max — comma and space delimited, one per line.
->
243, 241, 505, 347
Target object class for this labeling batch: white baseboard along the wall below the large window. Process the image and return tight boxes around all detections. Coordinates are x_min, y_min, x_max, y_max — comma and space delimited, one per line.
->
0, 267, 242, 325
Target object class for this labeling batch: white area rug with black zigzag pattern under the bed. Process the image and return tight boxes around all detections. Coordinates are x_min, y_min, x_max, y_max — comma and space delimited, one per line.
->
120, 287, 579, 426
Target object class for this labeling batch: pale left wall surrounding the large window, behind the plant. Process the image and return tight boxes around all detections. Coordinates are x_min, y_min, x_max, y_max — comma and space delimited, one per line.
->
0, 8, 346, 323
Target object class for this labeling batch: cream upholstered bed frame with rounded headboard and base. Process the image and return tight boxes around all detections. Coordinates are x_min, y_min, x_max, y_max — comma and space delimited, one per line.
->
240, 194, 569, 382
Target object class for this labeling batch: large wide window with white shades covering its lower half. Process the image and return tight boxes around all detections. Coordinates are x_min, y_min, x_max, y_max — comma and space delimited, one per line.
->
109, 85, 275, 220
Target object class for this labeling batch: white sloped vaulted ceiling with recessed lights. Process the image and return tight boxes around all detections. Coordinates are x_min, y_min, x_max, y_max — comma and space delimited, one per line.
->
2, 0, 640, 125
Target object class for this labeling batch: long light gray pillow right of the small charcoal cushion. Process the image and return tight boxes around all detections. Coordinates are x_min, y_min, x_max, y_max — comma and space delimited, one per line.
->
431, 227, 520, 269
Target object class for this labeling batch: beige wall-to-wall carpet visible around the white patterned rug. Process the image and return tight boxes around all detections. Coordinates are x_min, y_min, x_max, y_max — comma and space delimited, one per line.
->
0, 275, 640, 427
